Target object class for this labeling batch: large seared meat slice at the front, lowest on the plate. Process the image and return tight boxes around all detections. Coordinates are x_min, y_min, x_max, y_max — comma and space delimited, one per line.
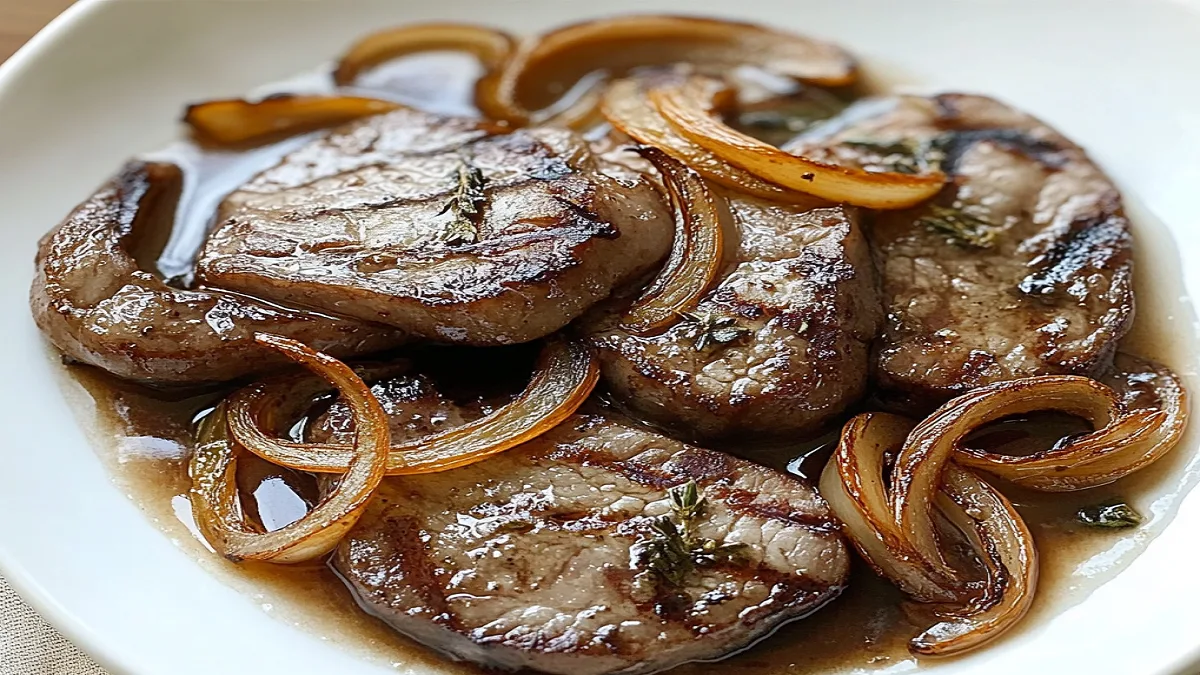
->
312, 393, 848, 675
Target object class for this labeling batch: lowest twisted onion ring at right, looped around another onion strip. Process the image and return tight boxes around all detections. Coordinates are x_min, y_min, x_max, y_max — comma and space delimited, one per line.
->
821, 413, 1038, 656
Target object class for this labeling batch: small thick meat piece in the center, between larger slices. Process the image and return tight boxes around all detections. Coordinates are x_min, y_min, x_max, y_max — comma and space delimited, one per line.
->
590, 195, 880, 438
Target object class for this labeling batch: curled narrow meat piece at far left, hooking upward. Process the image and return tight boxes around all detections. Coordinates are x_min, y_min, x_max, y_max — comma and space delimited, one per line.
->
30, 162, 402, 383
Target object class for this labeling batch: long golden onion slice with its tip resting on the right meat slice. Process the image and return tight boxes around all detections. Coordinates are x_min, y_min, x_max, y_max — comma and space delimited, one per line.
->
649, 74, 946, 209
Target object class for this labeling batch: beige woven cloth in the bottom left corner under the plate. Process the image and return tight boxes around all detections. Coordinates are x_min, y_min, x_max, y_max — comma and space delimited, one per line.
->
0, 578, 106, 675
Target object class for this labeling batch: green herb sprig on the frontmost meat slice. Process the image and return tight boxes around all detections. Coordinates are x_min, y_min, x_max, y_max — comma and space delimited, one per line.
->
634, 480, 745, 599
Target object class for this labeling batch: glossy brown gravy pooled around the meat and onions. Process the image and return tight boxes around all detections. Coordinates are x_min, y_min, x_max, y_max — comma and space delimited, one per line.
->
51, 55, 1200, 675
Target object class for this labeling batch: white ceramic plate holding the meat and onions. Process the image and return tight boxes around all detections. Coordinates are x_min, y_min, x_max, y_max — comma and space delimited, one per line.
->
0, 0, 1200, 675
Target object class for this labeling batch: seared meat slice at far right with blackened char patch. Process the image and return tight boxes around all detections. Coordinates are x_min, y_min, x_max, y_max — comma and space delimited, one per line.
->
791, 94, 1134, 410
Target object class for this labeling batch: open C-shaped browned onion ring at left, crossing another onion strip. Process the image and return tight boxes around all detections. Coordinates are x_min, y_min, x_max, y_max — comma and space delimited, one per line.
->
188, 334, 391, 563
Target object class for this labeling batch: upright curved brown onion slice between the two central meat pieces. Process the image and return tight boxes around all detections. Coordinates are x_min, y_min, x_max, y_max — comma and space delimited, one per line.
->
620, 148, 725, 334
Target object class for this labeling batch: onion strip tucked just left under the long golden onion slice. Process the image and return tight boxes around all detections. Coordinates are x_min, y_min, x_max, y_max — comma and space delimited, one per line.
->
601, 79, 808, 202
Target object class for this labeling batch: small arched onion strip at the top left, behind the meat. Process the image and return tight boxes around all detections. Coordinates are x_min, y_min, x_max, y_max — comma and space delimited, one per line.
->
334, 23, 516, 89
